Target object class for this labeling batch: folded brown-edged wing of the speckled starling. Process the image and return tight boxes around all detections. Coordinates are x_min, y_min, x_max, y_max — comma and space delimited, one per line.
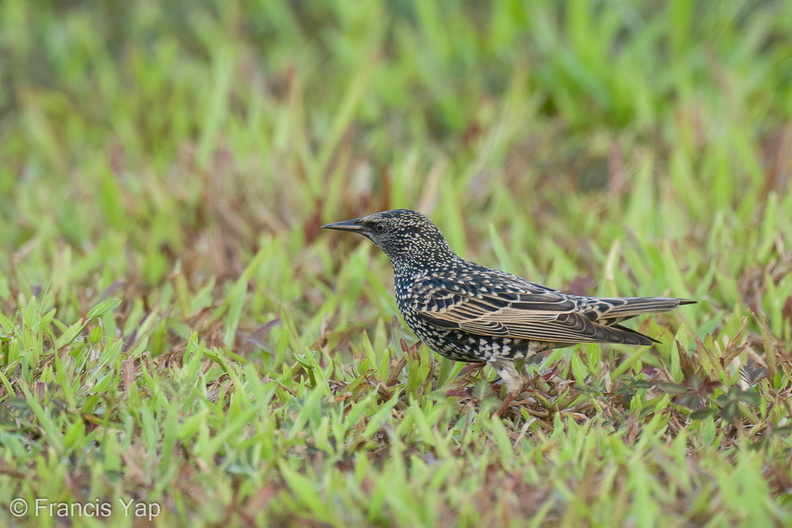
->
412, 280, 653, 345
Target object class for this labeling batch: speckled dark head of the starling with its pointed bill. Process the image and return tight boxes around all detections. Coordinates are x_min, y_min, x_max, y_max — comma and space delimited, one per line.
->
322, 209, 453, 266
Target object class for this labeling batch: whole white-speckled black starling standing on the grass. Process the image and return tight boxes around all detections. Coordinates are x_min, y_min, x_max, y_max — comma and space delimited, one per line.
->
322, 209, 695, 395
